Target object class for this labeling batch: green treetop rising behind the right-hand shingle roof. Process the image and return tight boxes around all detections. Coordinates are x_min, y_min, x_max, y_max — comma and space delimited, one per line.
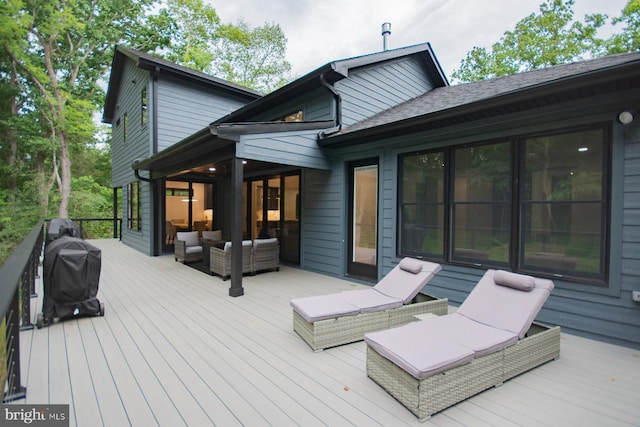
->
452, 0, 608, 82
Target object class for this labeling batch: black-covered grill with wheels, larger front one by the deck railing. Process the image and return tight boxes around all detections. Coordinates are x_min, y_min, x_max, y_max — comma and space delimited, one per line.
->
43, 236, 102, 319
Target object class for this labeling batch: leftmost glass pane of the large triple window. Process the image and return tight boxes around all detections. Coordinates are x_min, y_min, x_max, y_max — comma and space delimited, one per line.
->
400, 152, 445, 258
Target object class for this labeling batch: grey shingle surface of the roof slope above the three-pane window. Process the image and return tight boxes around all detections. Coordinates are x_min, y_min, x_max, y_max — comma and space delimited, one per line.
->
326, 52, 640, 144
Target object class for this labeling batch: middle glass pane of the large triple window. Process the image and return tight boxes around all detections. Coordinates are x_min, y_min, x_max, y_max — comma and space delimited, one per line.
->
452, 143, 511, 264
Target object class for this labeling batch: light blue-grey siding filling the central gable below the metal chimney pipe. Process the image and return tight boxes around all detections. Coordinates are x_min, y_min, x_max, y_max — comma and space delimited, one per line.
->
335, 57, 434, 126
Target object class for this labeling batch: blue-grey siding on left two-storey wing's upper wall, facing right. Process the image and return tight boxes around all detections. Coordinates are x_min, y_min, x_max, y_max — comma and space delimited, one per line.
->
157, 78, 251, 151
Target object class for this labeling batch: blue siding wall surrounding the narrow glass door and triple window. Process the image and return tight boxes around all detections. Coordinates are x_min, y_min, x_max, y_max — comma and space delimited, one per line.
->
301, 90, 640, 348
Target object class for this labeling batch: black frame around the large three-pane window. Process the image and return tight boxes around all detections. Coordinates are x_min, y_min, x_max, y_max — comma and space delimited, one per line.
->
396, 123, 613, 288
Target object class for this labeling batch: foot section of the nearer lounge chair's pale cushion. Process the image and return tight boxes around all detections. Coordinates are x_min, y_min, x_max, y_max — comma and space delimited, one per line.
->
364, 321, 474, 379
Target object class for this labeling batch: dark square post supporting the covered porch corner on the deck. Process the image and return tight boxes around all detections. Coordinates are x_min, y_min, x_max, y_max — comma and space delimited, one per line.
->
229, 157, 244, 297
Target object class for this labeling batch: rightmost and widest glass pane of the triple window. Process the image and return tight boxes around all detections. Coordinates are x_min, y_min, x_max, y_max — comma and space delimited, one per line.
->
521, 130, 606, 278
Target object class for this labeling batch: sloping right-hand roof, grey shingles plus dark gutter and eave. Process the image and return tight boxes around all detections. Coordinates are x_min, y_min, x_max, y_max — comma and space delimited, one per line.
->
319, 52, 640, 147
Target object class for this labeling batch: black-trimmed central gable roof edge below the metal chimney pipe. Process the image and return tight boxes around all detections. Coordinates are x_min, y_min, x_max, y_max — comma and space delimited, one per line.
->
214, 43, 449, 123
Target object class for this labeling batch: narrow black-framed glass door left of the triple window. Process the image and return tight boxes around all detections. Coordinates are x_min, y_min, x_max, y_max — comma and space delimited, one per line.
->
347, 159, 378, 281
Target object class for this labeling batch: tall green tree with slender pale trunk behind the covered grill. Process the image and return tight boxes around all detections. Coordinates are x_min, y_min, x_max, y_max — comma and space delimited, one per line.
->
0, 0, 160, 221
